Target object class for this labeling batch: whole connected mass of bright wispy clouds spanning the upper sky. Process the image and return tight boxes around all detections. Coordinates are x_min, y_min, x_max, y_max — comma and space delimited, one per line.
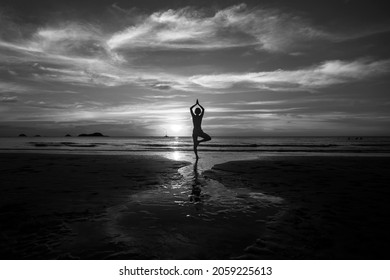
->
0, 4, 389, 93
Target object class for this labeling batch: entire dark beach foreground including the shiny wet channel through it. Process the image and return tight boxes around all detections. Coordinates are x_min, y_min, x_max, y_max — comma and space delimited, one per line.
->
0, 152, 390, 259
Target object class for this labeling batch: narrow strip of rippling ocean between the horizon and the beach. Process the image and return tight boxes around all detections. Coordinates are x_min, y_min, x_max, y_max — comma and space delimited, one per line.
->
0, 137, 390, 155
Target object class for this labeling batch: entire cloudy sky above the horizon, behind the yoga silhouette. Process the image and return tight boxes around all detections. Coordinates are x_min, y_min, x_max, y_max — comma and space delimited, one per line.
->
0, 0, 390, 136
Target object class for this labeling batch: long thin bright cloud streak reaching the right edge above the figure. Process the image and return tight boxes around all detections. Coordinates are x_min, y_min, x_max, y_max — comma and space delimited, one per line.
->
189, 59, 390, 91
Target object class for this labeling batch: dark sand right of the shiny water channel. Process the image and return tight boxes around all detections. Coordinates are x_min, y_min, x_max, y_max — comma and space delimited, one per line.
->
205, 156, 390, 259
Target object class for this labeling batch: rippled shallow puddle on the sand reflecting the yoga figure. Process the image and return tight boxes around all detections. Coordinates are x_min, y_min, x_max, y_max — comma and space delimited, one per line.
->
102, 159, 283, 259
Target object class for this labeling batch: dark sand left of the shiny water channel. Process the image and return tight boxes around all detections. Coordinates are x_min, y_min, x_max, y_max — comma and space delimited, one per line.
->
0, 153, 186, 259
